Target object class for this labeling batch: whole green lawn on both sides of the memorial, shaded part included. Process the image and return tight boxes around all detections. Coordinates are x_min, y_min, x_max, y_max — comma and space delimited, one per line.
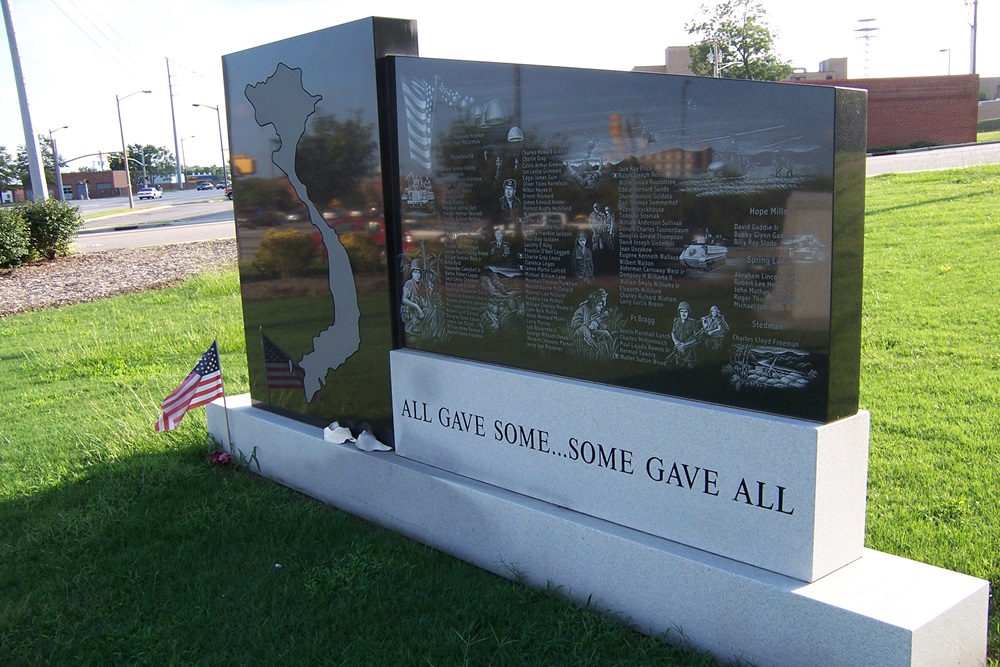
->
0, 166, 1000, 665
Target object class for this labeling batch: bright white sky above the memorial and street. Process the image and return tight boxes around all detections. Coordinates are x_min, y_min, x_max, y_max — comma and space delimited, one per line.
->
0, 0, 1000, 171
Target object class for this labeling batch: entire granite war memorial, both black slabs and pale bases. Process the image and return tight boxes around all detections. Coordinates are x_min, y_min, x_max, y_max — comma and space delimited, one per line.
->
213, 19, 989, 665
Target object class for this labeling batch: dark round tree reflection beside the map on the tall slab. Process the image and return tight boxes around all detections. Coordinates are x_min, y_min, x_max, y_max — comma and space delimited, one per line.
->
295, 111, 381, 208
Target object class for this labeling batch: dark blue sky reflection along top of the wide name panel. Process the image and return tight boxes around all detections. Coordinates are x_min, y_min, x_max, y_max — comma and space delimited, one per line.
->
397, 58, 833, 176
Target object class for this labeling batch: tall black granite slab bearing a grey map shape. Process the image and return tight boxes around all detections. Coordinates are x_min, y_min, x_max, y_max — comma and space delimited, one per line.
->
223, 18, 416, 438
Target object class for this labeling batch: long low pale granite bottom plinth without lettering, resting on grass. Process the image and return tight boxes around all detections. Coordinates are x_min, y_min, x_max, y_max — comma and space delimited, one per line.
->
207, 395, 989, 667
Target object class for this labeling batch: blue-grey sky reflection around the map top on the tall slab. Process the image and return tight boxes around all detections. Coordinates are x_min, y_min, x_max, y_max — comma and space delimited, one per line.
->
223, 21, 386, 172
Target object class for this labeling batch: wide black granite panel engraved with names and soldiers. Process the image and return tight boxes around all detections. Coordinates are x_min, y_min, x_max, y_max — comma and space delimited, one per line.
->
387, 57, 866, 422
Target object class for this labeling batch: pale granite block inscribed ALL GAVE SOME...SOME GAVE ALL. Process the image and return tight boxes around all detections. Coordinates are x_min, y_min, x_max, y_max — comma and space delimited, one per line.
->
390, 350, 869, 581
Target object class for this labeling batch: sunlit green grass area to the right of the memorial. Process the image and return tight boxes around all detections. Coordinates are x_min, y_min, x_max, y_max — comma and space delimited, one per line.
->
861, 165, 1000, 658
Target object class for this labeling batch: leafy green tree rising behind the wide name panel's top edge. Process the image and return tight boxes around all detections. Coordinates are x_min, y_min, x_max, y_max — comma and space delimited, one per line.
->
684, 0, 792, 81
